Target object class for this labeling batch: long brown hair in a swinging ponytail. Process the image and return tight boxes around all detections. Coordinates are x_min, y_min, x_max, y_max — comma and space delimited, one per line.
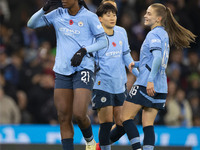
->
151, 3, 196, 48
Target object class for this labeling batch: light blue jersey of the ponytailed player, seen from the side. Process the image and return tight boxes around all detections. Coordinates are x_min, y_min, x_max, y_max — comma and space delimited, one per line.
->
134, 26, 170, 93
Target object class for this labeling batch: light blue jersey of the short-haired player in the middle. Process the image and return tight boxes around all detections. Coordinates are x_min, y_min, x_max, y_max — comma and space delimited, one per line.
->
94, 28, 133, 94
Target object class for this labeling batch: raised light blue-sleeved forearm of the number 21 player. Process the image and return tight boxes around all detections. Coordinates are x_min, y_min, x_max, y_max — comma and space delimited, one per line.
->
27, 8, 46, 29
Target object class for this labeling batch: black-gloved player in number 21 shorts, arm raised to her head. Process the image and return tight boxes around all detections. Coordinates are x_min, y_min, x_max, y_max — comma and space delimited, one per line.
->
28, 0, 108, 150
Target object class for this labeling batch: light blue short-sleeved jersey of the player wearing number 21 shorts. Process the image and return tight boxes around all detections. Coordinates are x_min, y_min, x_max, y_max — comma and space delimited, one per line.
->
43, 7, 105, 75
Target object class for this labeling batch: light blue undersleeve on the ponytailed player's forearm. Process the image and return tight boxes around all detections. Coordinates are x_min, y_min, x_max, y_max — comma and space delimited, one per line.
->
148, 50, 162, 82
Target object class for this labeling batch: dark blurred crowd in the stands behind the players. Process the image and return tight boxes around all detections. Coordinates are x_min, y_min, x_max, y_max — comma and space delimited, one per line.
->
0, 0, 200, 126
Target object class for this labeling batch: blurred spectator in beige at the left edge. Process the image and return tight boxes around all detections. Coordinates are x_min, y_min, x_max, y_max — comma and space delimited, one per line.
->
0, 86, 21, 124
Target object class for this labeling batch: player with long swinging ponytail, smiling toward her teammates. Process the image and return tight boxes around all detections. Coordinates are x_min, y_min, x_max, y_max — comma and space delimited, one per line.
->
122, 3, 196, 150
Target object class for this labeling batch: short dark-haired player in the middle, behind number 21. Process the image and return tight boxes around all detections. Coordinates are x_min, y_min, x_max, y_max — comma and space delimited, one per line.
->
92, 3, 138, 150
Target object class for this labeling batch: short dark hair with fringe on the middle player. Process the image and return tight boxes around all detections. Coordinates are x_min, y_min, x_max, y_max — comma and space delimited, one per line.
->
96, 3, 117, 17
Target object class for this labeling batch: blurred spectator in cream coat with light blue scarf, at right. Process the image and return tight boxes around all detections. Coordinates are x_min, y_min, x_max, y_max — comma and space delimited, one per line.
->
164, 88, 192, 127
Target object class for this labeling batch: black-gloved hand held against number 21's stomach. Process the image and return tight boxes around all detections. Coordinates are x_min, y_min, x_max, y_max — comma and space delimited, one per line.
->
71, 48, 87, 67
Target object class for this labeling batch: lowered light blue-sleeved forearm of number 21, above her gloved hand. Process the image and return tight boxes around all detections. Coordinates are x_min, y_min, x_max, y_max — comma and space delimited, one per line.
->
85, 35, 108, 53
